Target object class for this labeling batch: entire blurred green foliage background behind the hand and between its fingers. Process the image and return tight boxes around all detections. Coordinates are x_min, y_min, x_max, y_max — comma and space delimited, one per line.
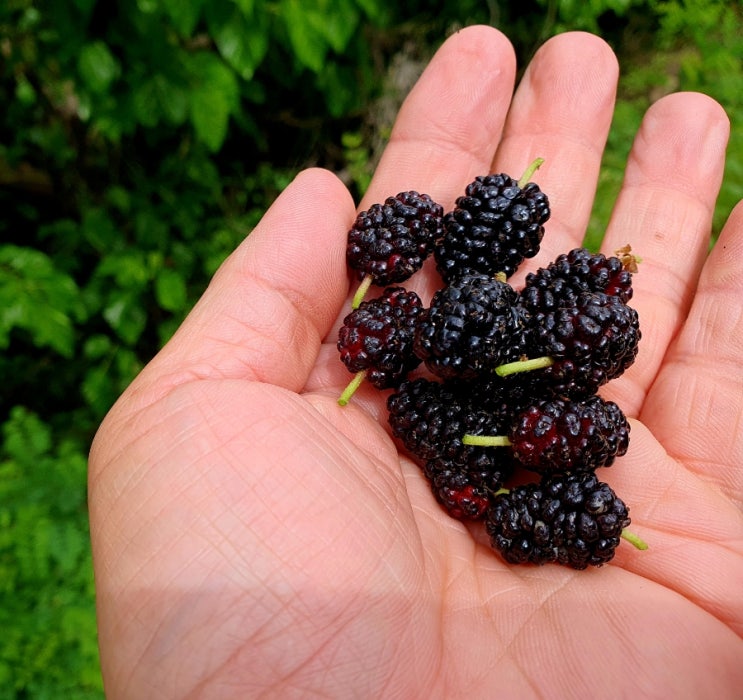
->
0, 0, 743, 700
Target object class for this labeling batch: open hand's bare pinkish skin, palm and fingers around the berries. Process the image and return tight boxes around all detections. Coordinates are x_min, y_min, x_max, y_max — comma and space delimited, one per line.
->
89, 27, 743, 700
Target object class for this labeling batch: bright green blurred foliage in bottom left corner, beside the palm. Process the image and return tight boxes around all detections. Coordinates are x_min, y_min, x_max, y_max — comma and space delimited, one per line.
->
0, 407, 102, 698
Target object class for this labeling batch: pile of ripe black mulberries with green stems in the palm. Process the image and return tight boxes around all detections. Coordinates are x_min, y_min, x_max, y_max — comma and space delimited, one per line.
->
337, 159, 646, 569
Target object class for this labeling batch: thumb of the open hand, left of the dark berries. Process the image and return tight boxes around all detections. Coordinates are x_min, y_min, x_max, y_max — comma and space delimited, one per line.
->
130, 169, 354, 401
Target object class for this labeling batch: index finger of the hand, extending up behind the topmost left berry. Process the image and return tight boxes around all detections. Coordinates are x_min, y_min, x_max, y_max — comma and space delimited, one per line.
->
361, 26, 516, 209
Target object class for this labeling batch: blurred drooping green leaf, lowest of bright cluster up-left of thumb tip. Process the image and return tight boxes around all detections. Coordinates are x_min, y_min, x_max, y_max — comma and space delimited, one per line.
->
190, 51, 239, 152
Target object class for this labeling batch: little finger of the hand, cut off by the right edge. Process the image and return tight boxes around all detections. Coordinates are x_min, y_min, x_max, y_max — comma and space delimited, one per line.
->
640, 202, 743, 509
